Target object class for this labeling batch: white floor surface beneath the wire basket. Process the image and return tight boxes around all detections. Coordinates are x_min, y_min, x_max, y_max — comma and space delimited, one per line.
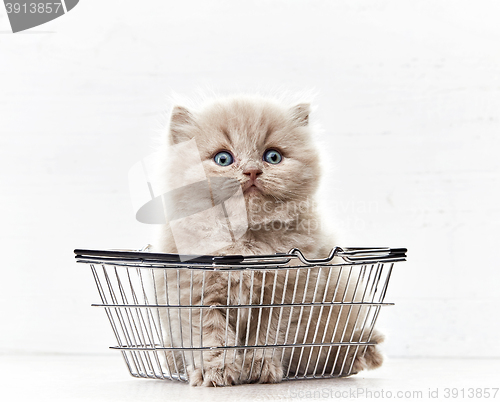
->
0, 352, 500, 402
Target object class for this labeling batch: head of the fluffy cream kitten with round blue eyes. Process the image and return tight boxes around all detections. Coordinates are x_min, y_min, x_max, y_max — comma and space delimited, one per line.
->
169, 96, 319, 226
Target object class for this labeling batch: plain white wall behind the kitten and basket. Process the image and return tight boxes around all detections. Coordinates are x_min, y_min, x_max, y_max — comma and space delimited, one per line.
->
0, 0, 500, 357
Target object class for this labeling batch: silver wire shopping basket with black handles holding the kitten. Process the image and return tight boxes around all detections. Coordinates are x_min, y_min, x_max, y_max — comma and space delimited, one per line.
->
75, 247, 406, 383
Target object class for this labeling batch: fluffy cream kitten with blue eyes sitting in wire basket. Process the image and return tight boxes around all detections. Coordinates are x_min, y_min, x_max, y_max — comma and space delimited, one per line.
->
153, 96, 383, 386
